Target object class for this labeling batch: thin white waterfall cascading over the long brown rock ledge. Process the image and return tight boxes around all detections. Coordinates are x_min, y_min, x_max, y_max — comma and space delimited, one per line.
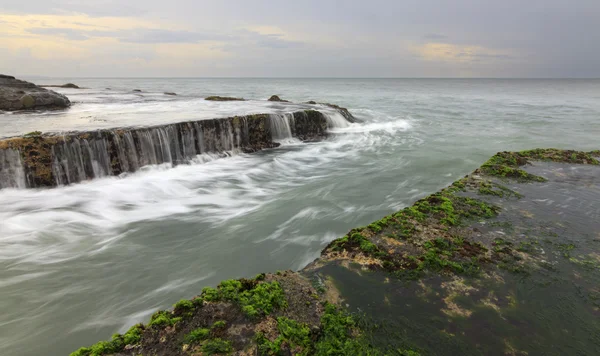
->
0, 110, 348, 188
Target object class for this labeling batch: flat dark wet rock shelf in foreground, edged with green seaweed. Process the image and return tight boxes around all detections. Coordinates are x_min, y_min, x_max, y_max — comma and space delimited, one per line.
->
72, 149, 600, 356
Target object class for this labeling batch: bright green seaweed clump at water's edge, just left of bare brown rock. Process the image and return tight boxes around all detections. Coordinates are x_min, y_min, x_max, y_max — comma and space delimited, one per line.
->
202, 279, 287, 318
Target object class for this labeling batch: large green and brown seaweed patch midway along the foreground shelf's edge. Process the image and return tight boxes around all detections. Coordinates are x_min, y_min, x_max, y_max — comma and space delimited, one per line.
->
324, 184, 499, 279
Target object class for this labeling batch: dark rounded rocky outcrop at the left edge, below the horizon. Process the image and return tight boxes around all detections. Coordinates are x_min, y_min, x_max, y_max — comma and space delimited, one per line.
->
0, 75, 71, 111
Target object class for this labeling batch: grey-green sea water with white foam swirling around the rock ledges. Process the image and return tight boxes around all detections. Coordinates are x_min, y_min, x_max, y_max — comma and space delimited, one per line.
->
0, 78, 600, 356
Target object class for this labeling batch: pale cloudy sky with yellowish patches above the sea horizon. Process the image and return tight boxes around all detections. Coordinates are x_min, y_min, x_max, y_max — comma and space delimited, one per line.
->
0, 0, 600, 78
